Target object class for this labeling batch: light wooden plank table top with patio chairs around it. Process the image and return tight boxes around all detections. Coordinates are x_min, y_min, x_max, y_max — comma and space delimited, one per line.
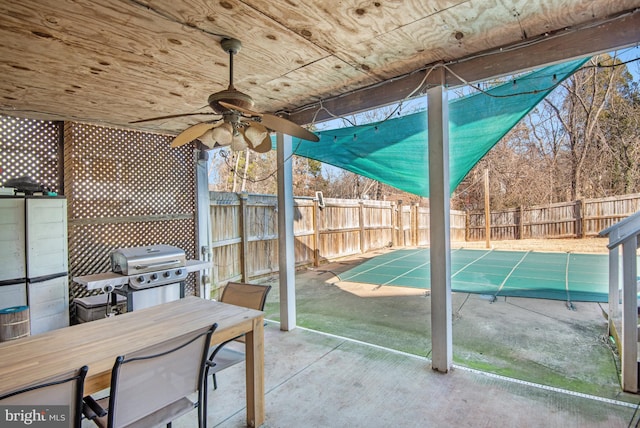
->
0, 297, 264, 395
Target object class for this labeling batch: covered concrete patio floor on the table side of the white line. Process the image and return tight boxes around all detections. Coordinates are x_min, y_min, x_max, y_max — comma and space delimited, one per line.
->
173, 322, 638, 428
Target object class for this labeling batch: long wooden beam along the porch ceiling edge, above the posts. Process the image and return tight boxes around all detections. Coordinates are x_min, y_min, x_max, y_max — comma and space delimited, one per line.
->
286, 9, 640, 125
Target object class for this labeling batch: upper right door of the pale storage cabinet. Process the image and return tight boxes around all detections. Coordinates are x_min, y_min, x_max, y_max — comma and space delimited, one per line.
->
25, 197, 68, 279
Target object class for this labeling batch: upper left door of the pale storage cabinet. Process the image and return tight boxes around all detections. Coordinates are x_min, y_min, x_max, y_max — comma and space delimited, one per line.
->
0, 198, 27, 281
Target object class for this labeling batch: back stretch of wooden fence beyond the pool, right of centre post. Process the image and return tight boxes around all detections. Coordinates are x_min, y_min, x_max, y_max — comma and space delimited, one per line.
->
466, 193, 640, 241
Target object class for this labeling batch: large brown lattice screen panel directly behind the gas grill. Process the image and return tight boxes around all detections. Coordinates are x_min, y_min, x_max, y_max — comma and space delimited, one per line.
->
64, 123, 198, 297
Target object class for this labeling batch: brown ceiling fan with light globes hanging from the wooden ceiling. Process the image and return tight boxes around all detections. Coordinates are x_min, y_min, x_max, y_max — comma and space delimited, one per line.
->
131, 38, 319, 153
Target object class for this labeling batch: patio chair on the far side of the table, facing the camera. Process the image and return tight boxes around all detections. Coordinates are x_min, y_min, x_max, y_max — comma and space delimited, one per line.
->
205, 282, 271, 389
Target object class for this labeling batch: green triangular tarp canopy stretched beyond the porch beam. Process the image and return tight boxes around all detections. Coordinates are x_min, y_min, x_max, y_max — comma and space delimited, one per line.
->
293, 58, 589, 197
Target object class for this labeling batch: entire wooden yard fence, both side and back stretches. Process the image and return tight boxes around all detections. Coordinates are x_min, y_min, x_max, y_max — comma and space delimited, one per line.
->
209, 192, 640, 289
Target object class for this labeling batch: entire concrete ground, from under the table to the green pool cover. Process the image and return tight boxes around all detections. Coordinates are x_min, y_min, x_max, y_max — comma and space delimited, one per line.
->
148, 242, 640, 428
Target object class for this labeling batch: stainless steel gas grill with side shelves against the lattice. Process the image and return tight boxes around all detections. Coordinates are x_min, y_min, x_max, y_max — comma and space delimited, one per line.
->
73, 245, 208, 311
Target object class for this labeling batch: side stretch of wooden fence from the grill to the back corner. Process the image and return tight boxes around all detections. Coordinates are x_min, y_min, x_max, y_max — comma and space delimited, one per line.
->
209, 192, 465, 289
